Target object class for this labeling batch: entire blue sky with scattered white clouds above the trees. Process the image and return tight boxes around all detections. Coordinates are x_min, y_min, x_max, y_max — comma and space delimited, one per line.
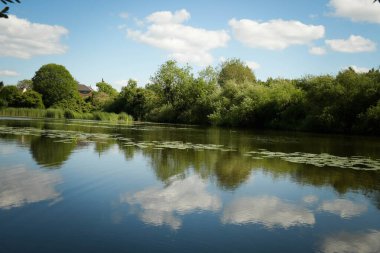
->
0, 0, 380, 89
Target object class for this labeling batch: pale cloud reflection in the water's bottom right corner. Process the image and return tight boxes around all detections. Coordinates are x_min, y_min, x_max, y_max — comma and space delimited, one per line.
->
321, 230, 380, 253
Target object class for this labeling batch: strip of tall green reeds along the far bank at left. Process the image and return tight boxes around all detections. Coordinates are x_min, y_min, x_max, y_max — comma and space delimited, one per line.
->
0, 108, 133, 122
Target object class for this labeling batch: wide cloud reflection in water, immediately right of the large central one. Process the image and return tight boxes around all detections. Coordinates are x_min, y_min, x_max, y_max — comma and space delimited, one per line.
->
222, 196, 315, 228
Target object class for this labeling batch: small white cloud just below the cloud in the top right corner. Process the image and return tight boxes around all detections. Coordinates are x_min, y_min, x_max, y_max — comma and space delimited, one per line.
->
326, 35, 376, 53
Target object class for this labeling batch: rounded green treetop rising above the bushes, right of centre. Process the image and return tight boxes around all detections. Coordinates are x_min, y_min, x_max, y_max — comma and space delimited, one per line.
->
218, 59, 256, 87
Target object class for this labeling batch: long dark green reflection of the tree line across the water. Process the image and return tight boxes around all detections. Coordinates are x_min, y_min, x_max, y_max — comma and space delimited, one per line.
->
0, 121, 380, 208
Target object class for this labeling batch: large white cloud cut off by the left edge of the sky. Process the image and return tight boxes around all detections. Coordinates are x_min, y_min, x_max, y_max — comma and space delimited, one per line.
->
0, 15, 68, 59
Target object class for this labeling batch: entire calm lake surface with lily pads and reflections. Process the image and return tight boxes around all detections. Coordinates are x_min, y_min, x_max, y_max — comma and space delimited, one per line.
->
0, 118, 380, 253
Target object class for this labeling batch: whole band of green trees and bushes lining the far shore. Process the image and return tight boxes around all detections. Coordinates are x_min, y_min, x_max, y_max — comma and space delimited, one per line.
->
0, 59, 380, 134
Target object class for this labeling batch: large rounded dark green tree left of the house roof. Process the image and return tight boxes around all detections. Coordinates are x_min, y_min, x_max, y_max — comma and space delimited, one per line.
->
32, 63, 81, 108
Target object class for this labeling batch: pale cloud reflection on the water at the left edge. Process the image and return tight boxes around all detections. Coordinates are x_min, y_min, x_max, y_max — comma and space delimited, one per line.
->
0, 166, 61, 209
